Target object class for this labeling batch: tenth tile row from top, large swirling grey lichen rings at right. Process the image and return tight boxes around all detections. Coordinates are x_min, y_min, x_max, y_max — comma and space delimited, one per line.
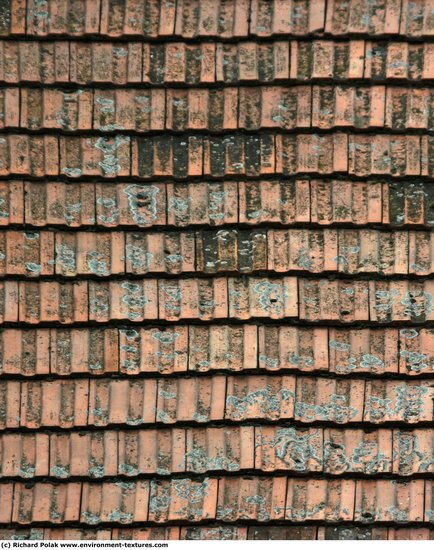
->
0, 426, 434, 479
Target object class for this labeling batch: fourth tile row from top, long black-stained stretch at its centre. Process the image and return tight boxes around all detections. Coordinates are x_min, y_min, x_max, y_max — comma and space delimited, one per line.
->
0, 133, 434, 178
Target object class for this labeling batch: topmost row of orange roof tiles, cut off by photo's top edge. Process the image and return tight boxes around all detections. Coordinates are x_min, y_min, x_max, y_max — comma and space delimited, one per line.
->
0, 0, 434, 38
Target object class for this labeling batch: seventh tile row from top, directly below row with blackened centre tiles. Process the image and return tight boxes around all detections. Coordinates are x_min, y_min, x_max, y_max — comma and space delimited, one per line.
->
0, 277, 434, 324
